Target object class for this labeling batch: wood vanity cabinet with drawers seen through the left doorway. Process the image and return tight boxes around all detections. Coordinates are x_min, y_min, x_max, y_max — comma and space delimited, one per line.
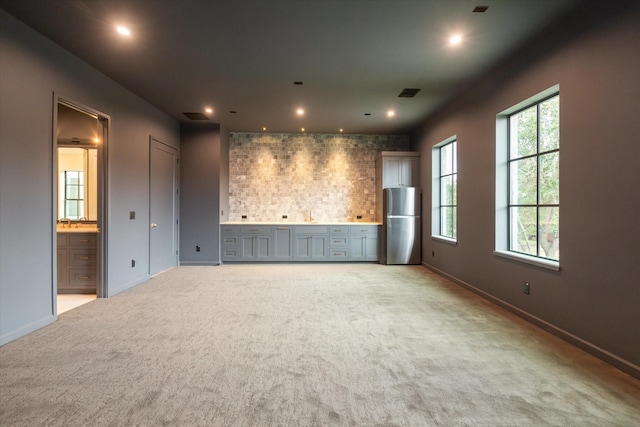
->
57, 232, 98, 294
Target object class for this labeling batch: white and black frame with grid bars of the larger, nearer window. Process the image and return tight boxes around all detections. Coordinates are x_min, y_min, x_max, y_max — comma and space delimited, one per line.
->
494, 85, 560, 271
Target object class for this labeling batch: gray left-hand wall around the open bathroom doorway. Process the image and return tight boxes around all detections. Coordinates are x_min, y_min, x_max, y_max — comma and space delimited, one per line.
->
0, 10, 179, 344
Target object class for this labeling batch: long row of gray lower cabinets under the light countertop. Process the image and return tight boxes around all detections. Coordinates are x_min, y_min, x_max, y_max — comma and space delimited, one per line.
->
220, 224, 378, 262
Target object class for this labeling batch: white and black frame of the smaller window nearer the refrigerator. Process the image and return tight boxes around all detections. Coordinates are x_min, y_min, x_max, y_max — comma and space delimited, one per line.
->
431, 135, 458, 244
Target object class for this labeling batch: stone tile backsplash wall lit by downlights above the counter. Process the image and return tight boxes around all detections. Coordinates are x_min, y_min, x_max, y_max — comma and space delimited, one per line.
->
229, 132, 410, 222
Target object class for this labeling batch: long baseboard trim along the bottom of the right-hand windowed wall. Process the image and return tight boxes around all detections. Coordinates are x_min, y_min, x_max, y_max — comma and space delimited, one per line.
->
422, 262, 640, 379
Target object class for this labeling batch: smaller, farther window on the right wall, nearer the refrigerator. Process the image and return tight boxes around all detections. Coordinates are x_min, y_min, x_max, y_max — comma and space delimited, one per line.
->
432, 136, 458, 241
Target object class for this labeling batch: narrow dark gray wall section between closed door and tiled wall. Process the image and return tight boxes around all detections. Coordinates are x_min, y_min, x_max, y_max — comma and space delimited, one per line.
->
180, 123, 224, 265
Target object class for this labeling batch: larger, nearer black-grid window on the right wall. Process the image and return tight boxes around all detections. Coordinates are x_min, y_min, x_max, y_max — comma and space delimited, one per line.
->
496, 87, 560, 268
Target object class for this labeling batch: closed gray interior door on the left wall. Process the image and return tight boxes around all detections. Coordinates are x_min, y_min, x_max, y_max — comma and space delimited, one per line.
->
149, 138, 178, 275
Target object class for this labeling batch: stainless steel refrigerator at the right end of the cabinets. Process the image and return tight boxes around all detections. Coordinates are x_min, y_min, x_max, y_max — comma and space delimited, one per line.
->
380, 187, 421, 264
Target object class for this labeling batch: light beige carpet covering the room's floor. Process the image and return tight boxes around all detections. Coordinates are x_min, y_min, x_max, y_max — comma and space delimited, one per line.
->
0, 264, 640, 426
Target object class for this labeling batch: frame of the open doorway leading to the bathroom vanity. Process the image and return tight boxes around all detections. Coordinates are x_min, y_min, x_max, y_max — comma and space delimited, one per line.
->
51, 92, 111, 310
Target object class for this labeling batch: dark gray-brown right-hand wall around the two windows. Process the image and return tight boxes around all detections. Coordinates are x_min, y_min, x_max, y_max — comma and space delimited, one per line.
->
414, 3, 640, 376
